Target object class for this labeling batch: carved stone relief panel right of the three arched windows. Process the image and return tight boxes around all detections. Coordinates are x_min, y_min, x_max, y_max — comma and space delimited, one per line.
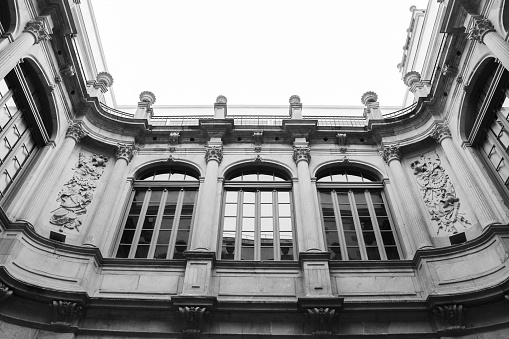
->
411, 153, 470, 235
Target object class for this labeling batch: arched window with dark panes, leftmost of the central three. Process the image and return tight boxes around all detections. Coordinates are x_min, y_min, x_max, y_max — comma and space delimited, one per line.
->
116, 168, 199, 259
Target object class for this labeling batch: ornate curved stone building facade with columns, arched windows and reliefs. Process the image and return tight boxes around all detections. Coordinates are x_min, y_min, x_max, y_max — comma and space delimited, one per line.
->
0, 0, 509, 339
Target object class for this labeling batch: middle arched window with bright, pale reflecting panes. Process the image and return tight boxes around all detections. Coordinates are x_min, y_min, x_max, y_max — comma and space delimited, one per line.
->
220, 169, 295, 260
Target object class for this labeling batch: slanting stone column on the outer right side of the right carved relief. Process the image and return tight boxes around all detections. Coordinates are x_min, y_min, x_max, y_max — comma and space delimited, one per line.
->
431, 124, 499, 229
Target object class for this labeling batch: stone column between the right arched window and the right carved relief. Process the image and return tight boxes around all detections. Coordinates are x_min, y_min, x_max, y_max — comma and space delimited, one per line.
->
381, 146, 433, 250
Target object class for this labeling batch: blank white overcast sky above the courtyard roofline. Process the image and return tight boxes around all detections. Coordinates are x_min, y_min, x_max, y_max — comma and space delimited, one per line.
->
92, 0, 428, 106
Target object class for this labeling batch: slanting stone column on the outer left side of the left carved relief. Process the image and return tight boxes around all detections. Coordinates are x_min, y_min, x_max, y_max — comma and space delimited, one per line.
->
18, 122, 85, 224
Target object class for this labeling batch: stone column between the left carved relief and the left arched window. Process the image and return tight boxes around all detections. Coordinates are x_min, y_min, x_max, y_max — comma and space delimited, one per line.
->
83, 144, 134, 248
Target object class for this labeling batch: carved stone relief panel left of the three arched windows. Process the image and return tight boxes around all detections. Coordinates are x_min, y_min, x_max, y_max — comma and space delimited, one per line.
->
50, 153, 108, 232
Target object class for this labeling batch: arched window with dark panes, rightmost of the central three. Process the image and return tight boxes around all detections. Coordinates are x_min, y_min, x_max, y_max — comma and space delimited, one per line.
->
317, 168, 401, 260
